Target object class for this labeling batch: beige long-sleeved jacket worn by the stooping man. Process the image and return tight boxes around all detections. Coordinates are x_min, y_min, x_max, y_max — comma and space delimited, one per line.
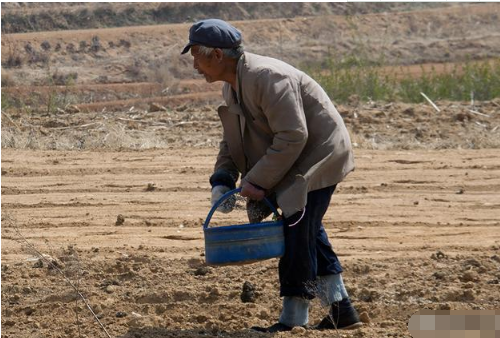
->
215, 53, 354, 217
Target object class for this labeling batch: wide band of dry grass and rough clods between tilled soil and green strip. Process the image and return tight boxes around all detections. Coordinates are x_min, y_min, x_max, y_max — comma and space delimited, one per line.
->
1, 86, 500, 150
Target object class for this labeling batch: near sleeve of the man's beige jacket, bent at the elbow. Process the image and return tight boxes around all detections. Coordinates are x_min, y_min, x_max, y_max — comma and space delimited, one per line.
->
245, 69, 308, 189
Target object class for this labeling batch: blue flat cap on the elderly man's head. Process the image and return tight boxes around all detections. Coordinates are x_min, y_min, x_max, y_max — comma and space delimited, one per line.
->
181, 19, 241, 54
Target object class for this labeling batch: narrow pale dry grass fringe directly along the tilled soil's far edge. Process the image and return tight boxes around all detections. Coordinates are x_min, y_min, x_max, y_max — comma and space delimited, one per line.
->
2, 117, 500, 150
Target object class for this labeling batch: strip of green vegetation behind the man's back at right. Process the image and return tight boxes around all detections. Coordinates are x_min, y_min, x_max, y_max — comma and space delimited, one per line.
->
307, 54, 500, 103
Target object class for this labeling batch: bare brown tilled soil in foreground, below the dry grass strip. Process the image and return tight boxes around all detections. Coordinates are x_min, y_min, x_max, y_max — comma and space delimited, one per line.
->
2, 148, 500, 338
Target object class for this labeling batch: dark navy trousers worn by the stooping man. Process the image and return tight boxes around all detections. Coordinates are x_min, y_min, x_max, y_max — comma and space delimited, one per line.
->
278, 185, 342, 299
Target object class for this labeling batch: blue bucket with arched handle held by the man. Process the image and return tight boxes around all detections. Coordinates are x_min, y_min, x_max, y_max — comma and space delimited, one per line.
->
203, 188, 285, 265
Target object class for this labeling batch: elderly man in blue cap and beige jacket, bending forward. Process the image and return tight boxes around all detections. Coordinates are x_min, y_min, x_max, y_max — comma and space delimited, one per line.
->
182, 19, 362, 332
